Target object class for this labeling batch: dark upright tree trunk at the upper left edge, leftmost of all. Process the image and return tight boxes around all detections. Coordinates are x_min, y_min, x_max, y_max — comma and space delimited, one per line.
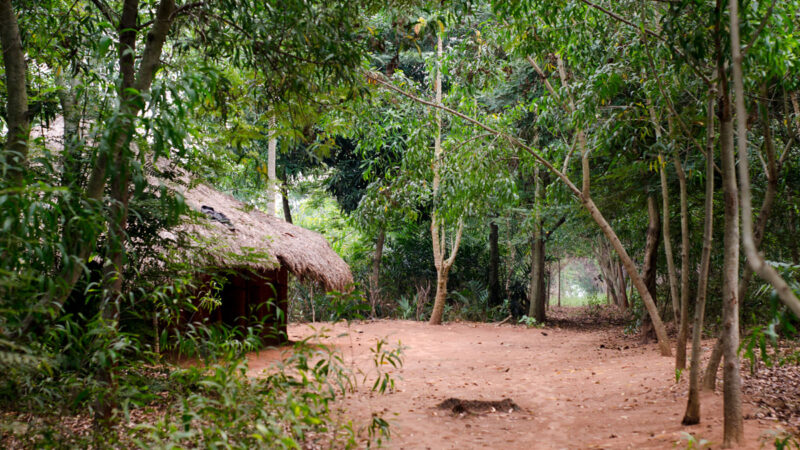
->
0, 0, 30, 184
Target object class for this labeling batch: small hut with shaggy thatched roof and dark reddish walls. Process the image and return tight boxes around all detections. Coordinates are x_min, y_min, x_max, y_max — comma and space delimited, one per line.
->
31, 118, 353, 343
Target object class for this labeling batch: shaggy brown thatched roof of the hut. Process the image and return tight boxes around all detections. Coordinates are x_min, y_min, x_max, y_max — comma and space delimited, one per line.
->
170, 176, 353, 291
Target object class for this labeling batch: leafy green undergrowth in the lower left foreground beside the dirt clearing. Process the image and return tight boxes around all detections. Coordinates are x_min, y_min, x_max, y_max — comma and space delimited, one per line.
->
0, 327, 403, 448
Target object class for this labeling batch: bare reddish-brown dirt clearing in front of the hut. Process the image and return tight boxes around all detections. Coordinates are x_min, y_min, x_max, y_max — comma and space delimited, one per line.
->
250, 320, 779, 449
